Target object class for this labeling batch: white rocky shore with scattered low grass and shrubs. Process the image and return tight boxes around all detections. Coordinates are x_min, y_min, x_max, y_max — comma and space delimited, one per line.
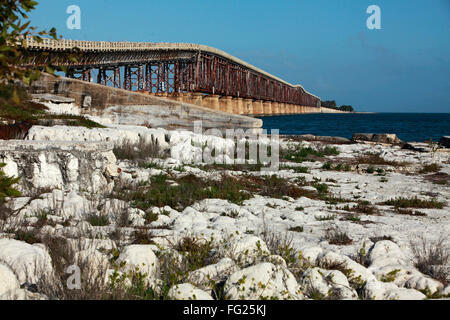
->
0, 100, 450, 300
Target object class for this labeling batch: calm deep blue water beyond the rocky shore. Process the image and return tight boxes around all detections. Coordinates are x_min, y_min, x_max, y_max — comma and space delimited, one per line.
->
260, 113, 450, 142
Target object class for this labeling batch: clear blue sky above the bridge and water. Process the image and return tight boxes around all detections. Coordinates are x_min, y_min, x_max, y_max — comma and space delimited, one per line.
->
31, 0, 450, 112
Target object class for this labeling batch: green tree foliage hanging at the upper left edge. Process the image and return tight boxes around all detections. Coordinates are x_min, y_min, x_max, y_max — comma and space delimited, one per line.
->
0, 0, 57, 89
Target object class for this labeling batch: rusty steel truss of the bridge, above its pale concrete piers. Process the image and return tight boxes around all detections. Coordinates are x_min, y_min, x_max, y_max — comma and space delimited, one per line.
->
23, 38, 320, 107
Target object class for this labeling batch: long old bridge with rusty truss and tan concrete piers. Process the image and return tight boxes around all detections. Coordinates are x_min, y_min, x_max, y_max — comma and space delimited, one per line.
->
25, 37, 321, 115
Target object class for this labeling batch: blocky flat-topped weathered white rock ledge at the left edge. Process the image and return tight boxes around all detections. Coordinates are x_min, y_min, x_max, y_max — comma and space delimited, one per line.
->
0, 140, 118, 193
